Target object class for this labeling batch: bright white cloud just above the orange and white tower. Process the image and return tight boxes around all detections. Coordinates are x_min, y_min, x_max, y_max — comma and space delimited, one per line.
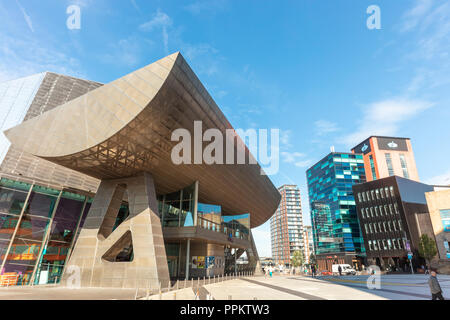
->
343, 98, 432, 146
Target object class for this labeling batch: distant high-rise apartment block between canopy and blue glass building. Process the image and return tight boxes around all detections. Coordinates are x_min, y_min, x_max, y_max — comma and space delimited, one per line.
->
270, 185, 304, 265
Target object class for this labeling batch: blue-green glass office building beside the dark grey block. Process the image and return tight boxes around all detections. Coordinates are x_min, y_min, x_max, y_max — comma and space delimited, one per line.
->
306, 153, 366, 254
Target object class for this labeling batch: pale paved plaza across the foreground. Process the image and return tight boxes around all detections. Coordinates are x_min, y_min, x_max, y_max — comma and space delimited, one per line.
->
0, 275, 450, 300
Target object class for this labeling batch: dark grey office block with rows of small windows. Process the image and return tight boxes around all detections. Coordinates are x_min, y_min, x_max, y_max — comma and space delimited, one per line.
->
353, 176, 433, 270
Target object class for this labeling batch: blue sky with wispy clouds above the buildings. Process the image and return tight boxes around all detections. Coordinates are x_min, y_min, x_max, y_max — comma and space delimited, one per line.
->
0, 0, 450, 256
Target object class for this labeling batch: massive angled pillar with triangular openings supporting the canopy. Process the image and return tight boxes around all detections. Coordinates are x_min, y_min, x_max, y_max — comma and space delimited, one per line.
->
62, 173, 169, 288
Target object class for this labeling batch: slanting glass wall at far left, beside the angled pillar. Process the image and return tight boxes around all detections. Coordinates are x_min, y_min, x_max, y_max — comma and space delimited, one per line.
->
0, 178, 92, 285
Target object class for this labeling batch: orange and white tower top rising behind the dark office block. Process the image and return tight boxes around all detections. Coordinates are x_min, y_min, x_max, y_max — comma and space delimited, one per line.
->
352, 136, 419, 181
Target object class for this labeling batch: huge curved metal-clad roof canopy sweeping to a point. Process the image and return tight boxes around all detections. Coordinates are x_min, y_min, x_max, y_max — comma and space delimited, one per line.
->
5, 53, 280, 227
